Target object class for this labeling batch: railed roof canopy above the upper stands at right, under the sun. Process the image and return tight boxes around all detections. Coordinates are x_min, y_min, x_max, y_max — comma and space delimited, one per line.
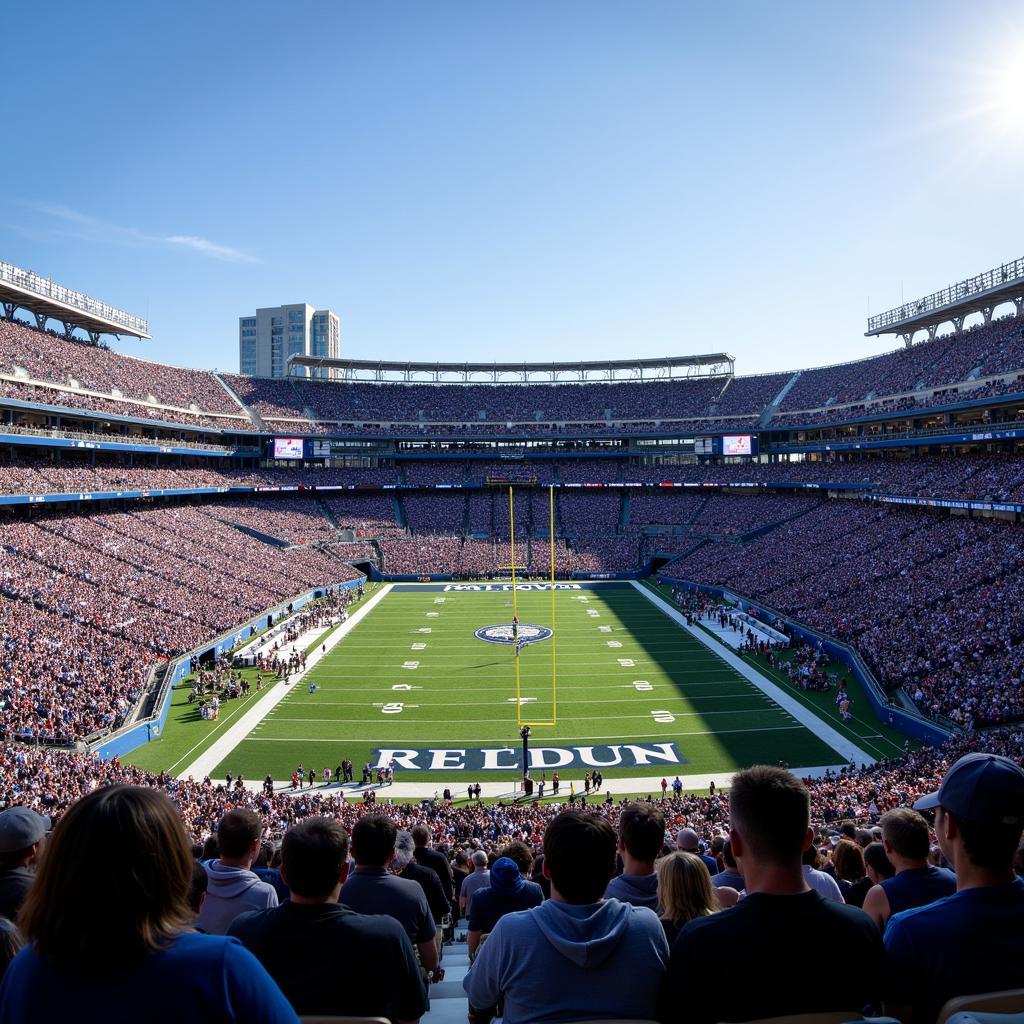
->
865, 258, 1024, 345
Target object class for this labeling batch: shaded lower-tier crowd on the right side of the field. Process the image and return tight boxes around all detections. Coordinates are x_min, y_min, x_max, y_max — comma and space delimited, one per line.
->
665, 503, 1024, 727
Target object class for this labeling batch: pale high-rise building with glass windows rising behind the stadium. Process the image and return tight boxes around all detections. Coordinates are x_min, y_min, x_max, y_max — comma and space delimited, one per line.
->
239, 302, 341, 377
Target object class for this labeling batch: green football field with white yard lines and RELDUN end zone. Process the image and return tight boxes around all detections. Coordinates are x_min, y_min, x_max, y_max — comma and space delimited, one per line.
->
214, 583, 864, 793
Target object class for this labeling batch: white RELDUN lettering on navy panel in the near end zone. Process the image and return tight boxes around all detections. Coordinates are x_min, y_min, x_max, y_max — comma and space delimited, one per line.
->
374, 742, 687, 772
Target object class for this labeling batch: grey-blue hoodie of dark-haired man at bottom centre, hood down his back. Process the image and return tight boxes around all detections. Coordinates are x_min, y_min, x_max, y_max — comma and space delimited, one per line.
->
463, 899, 669, 1024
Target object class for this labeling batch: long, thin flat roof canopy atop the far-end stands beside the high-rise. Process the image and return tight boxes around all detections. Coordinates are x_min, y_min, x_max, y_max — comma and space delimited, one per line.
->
288, 352, 735, 384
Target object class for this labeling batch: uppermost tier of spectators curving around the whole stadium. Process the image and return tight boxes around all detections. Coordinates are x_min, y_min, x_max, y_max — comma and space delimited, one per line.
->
6, 317, 1024, 444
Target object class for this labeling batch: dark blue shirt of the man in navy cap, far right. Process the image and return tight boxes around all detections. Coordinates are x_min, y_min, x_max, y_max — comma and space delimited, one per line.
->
885, 879, 1024, 1024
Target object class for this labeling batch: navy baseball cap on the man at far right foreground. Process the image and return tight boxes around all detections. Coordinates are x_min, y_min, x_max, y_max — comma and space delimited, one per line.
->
913, 754, 1024, 827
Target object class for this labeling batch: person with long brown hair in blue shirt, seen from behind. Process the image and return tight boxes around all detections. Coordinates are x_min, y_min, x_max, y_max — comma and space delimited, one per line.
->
0, 785, 298, 1024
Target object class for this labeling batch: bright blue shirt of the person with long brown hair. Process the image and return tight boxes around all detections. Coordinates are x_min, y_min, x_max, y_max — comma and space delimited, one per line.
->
0, 933, 299, 1024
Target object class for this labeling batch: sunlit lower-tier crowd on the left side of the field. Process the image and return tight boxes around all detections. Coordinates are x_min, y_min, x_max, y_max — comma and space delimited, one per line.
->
0, 507, 357, 742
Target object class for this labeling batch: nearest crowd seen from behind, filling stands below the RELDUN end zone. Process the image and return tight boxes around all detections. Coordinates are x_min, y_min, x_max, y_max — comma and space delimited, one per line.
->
0, 729, 1024, 1024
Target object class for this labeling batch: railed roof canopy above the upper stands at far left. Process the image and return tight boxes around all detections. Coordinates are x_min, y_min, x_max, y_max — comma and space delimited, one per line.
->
0, 260, 150, 341
